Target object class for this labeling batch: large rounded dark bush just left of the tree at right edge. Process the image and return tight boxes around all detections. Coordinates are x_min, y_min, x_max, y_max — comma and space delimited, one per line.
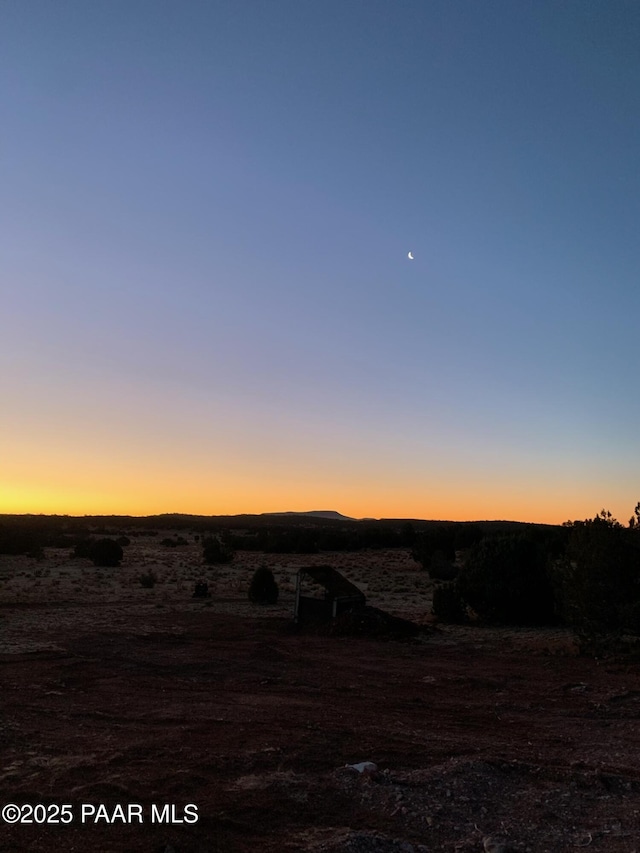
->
458, 534, 554, 624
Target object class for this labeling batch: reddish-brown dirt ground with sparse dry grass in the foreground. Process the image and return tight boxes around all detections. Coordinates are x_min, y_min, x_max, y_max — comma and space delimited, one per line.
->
0, 537, 640, 853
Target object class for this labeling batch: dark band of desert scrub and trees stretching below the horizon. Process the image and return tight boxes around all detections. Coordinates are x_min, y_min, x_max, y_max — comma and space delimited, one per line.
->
0, 504, 640, 651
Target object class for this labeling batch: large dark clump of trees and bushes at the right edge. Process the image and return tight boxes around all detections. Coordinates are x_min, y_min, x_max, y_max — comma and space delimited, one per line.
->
428, 503, 640, 650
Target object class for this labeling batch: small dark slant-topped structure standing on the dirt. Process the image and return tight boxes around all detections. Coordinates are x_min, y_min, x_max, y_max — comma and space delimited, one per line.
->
293, 566, 367, 622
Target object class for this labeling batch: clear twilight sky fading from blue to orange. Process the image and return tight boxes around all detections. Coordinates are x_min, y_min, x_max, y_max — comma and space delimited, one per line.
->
0, 0, 640, 523
